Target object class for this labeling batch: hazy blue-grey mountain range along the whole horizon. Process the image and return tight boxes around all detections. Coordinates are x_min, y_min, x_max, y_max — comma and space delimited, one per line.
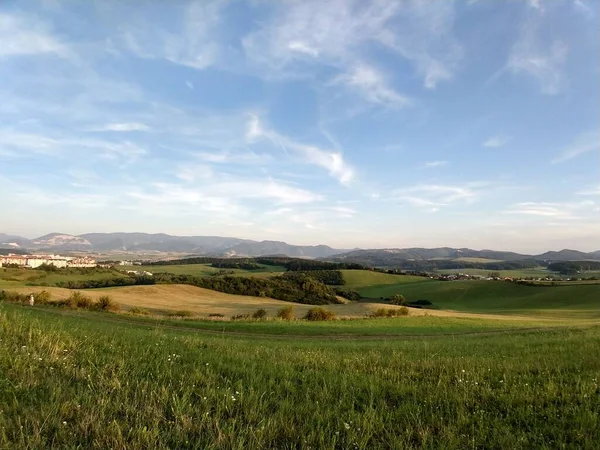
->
0, 233, 600, 266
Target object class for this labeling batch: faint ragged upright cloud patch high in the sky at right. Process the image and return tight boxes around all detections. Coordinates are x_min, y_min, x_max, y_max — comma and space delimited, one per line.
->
506, 21, 568, 95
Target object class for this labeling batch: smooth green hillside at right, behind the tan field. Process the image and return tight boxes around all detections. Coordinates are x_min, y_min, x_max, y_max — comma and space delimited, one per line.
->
359, 281, 600, 317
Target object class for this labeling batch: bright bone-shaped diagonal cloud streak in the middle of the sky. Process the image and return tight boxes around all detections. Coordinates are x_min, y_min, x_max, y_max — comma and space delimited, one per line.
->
246, 115, 354, 185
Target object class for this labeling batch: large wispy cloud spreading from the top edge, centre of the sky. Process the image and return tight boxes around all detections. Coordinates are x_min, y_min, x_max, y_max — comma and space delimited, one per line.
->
242, 0, 462, 88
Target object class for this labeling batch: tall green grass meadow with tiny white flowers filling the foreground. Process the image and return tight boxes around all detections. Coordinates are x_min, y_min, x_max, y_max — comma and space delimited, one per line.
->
0, 304, 600, 449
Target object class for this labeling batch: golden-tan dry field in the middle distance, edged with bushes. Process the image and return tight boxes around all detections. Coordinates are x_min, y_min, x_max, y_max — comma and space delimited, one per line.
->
11, 284, 580, 321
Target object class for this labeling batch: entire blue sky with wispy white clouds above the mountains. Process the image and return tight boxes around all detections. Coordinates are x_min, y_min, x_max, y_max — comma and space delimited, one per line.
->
0, 0, 600, 252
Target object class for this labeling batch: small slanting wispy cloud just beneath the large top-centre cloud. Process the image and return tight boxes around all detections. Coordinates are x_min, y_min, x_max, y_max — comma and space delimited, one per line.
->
334, 64, 411, 107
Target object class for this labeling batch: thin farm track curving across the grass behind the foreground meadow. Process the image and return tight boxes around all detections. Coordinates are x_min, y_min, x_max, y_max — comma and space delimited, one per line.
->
16, 308, 593, 341
